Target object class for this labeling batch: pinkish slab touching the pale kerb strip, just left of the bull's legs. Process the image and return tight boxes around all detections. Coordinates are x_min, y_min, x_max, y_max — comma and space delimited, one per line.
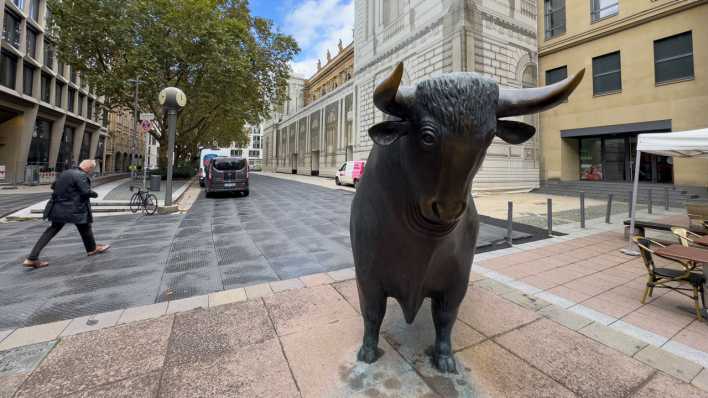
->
264, 285, 359, 336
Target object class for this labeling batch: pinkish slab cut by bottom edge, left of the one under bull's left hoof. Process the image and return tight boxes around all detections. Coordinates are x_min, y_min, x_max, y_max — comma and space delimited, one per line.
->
160, 339, 300, 398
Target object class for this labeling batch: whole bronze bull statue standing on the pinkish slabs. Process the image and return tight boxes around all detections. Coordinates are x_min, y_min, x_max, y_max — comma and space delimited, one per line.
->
350, 64, 584, 372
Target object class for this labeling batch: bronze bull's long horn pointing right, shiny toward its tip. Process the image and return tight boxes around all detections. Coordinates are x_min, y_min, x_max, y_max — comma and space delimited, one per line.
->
497, 69, 585, 117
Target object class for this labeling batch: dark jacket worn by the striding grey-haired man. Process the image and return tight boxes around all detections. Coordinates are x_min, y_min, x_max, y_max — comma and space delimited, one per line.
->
48, 168, 98, 224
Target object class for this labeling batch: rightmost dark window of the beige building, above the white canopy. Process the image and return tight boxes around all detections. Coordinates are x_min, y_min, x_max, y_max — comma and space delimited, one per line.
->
654, 32, 694, 83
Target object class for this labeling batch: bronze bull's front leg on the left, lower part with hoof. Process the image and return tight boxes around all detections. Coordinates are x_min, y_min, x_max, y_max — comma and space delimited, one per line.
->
357, 281, 386, 363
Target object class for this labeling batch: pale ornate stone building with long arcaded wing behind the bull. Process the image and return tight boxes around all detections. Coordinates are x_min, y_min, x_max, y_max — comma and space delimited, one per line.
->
264, 0, 539, 191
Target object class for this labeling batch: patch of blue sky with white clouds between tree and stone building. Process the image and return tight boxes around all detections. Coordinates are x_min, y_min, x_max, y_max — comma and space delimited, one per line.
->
250, 0, 354, 77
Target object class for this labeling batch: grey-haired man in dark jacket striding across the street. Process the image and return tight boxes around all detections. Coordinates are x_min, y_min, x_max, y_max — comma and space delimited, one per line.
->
22, 160, 110, 268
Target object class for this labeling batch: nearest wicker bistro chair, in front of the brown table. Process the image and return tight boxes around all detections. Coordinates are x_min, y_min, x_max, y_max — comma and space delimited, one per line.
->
632, 236, 706, 319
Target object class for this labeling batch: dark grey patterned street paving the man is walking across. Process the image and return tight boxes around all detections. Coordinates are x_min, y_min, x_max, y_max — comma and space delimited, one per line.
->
0, 175, 548, 330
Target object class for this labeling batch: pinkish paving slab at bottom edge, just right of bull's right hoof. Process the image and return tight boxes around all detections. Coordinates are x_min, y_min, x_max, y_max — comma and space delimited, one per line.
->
457, 341, 575, 398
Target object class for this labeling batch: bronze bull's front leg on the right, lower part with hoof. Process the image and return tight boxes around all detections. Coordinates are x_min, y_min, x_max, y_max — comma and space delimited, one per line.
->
432, 296, 459, 373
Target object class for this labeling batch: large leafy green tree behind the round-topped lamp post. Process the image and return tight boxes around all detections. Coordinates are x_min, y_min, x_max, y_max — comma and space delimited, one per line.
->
48, 0, 299, 164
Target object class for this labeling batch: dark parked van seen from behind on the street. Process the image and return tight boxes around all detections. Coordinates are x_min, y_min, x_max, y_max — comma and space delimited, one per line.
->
205, 156, 249, 196
